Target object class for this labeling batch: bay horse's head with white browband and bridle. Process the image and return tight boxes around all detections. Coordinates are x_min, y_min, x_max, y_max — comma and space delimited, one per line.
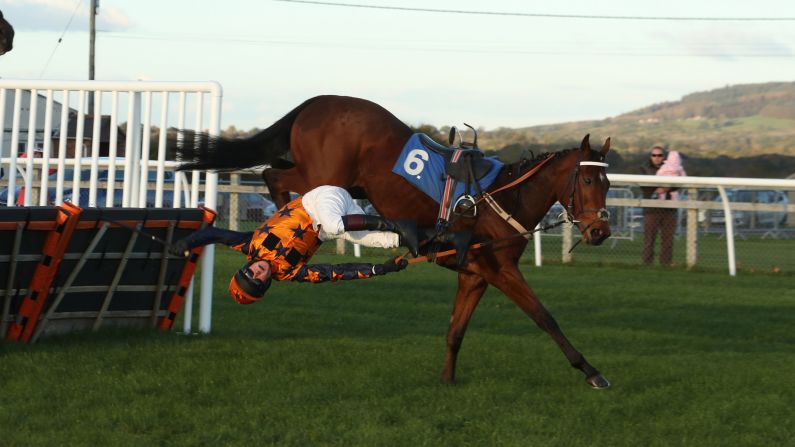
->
558, 135, 610, 245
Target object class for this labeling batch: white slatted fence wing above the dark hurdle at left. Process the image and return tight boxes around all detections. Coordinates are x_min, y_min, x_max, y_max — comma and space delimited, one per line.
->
0, 79, 222, 332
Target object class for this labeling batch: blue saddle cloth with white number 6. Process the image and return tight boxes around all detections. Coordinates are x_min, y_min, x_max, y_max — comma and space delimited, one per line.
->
392, 133, 503, 203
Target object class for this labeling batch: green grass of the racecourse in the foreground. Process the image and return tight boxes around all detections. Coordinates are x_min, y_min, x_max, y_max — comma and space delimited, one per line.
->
0, 248, 795, 446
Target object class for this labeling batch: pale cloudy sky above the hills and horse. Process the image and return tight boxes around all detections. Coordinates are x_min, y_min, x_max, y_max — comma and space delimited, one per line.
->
0, 0, 795, 129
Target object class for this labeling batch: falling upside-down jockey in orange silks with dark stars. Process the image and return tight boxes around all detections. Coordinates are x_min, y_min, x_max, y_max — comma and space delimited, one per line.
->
170, 186, 419, 304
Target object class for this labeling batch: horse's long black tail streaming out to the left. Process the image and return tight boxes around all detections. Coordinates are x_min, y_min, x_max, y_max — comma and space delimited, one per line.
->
177, 97, 317, 171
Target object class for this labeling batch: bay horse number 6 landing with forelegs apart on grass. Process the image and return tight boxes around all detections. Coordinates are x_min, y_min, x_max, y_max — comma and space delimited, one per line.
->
177, 96, 610, 388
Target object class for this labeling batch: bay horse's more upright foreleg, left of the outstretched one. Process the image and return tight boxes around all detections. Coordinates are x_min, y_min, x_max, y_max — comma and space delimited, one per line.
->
442, 272, 489, 384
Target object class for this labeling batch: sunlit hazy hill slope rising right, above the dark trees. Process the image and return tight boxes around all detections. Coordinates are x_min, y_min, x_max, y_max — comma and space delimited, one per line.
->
470, 82, 795, 158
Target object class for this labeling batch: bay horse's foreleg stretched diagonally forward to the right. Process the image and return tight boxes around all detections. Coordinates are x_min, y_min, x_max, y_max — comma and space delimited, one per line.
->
484, 265, 610, 389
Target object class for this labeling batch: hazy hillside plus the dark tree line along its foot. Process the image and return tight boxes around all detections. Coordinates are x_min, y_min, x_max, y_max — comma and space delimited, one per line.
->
222, 82, 795, 178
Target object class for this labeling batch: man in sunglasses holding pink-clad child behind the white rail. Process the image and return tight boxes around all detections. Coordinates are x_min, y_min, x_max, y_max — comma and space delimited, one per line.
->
640, 145, 684, 266
